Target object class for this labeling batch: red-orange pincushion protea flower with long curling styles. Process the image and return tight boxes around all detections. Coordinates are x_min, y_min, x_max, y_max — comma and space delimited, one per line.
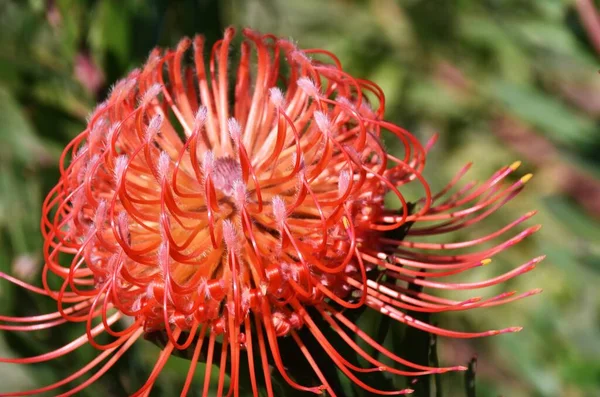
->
0, 28, 542, 396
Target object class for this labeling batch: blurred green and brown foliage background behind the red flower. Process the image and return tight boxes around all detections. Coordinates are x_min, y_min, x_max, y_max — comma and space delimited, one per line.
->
0, 0, 600, 397
